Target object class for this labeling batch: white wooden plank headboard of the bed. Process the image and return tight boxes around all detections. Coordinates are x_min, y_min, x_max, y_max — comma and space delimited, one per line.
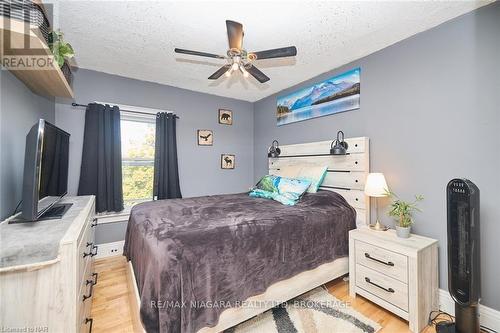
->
269, 137, 370, 227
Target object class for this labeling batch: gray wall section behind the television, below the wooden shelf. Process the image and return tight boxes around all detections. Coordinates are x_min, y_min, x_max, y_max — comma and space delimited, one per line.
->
0, 69, 54, 220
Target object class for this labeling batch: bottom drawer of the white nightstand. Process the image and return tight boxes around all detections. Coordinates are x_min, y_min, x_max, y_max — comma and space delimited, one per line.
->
356, 264, 408, 311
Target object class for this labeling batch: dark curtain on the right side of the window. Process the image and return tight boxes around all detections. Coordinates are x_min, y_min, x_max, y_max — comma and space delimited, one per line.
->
153, 112, 182, 200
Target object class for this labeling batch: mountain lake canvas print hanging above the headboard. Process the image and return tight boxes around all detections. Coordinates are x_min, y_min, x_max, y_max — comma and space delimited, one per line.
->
276, 68, 360, 126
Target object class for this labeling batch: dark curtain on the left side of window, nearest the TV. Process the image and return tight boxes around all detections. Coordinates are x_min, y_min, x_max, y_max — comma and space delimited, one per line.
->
78, 103, 123, 213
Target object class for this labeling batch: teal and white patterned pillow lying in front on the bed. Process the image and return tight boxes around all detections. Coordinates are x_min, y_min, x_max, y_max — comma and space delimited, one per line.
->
249, 175, 311, 206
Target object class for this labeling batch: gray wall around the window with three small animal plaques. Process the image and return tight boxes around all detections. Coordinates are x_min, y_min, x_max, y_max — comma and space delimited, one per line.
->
56, 70, 253, 243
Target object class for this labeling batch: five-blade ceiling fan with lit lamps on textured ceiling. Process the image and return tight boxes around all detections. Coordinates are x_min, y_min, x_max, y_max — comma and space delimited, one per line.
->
174, 20, 297, 83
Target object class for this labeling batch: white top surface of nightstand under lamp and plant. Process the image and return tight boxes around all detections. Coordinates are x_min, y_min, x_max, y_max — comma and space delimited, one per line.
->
349, 227, 437, 256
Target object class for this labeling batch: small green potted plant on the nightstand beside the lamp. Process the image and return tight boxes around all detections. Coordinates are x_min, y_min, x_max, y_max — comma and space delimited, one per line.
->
388, 192, 424, 238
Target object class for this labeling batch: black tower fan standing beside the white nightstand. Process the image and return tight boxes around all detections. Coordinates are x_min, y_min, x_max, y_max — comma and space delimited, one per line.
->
446, 179, 481, 333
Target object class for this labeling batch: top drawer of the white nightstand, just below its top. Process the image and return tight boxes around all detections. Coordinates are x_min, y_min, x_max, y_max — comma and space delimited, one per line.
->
354, 240, 408, 283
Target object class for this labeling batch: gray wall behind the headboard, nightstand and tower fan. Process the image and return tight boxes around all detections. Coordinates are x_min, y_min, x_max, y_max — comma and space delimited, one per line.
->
254, 3, 500, 309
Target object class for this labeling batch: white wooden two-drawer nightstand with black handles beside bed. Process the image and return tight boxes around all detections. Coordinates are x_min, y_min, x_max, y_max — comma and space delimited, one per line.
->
349, 227, 438, 332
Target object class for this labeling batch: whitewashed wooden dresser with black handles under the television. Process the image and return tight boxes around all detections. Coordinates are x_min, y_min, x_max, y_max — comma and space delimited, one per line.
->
0, 196, 98, 333
